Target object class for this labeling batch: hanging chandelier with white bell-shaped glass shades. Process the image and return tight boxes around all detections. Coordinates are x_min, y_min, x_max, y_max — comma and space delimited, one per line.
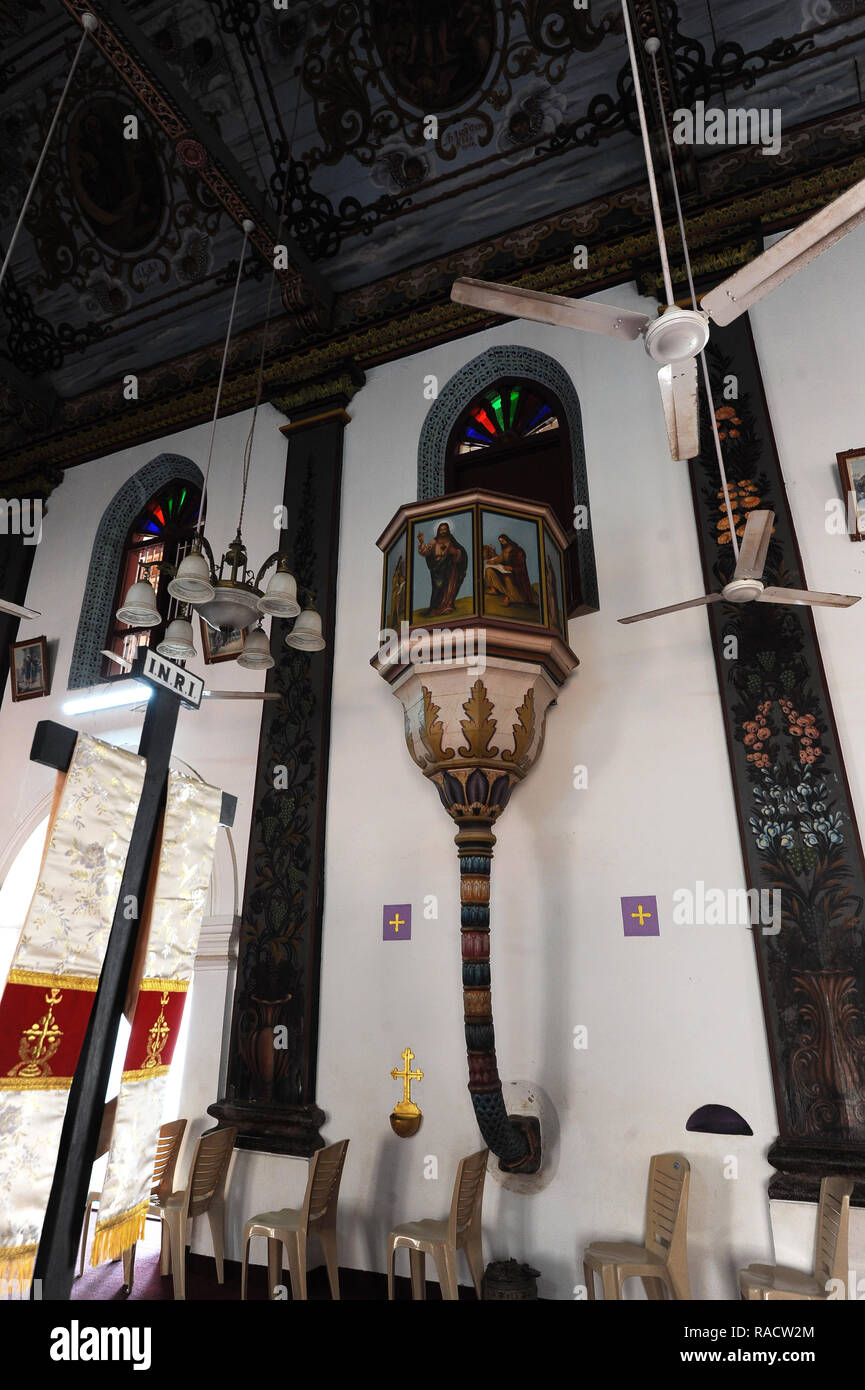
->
117, 218, 327, 670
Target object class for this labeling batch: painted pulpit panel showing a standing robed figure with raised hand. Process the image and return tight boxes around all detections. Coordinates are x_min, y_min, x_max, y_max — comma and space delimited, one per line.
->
412, 512, 476, 623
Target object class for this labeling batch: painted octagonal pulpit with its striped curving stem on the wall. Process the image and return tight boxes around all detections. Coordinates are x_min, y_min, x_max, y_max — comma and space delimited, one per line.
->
371, 489, 577, 1173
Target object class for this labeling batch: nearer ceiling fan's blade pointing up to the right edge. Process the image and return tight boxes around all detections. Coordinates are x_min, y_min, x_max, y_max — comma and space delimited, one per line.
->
700, 179, 865, 327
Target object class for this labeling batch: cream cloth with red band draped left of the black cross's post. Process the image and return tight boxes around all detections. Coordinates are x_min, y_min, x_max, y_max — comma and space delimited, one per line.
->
0, 734, 146, 1280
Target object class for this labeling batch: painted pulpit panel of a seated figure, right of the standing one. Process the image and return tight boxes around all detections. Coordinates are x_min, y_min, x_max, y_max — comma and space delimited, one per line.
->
481, 510, 544, 623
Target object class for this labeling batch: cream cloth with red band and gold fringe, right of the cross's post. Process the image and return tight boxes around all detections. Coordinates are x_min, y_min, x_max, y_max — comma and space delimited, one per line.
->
92, 773, 223, 1265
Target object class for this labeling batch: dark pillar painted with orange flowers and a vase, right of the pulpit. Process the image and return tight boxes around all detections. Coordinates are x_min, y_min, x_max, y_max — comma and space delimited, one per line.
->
695, 318, 865, 1195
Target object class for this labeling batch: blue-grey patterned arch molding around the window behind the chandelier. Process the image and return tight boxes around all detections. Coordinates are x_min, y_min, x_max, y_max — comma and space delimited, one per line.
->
67, 453, 204, 691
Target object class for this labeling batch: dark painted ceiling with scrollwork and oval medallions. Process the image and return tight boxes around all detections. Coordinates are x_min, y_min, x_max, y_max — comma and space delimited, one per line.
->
0, 0, 865, 478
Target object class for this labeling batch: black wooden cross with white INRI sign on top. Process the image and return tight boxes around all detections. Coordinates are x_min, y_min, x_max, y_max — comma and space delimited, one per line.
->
31, 648, 238, 1300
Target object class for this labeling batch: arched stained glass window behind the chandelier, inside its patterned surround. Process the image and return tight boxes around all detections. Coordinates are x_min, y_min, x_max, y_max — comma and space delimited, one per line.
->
103, 480, 202, 680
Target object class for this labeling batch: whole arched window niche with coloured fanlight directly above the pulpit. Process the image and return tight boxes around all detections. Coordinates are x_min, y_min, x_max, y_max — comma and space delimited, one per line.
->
417, 346, 598, 617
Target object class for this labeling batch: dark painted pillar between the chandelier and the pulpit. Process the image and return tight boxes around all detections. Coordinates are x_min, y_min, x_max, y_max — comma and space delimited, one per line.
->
209, 368, 363, 1155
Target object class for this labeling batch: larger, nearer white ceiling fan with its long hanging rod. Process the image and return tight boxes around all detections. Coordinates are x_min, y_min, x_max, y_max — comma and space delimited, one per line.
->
451, 0, 865, 459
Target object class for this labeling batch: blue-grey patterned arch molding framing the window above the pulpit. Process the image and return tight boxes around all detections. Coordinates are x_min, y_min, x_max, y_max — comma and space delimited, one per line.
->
417, 345, 598, 610
